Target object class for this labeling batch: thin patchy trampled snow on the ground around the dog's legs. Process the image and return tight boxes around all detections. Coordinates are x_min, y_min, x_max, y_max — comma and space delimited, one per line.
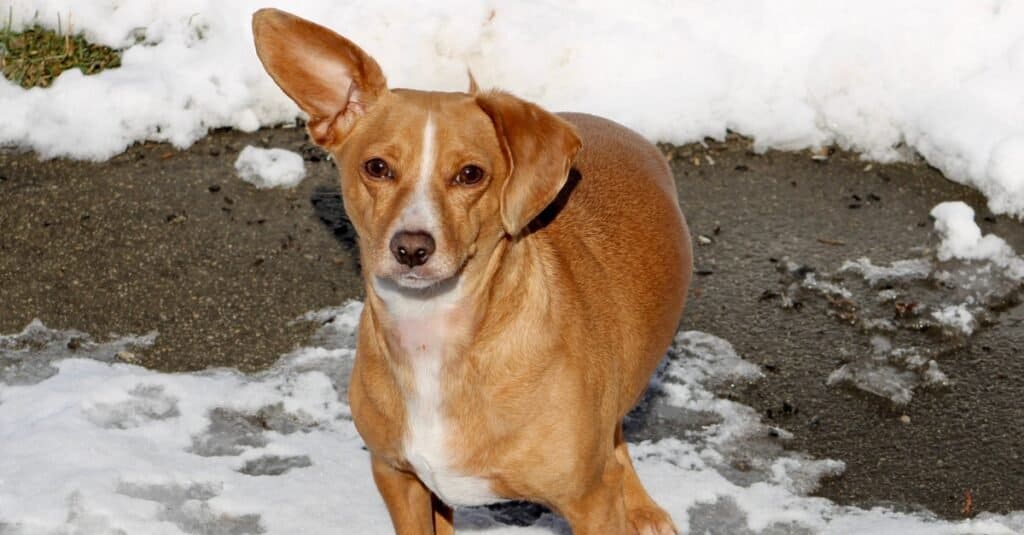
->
0, 302, 1024, 535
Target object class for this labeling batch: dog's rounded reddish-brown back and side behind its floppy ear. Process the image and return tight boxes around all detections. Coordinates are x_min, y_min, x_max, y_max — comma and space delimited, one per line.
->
530, 113, 692, 413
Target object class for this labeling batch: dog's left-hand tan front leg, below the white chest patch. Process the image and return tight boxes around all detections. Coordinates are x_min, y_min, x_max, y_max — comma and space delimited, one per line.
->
373, 456, 455, 535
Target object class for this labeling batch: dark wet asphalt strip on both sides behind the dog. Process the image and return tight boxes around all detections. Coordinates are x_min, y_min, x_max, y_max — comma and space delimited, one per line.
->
0, 124, 1024, 518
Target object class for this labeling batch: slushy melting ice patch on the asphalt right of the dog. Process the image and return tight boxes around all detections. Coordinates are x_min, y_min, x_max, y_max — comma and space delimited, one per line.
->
771, 202, 1024, 405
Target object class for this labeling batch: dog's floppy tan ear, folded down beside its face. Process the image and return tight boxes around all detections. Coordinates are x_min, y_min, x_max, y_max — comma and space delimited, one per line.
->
476, 91, 583, 236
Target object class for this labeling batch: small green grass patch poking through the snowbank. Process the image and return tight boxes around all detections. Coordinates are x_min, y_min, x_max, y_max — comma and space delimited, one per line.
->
0, 13, 121, 88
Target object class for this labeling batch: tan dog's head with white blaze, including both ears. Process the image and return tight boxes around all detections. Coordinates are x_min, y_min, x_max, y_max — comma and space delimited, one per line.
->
253, 9, 580, 289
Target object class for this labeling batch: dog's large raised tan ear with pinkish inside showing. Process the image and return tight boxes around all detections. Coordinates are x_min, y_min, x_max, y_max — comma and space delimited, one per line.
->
253, 9, 387, 147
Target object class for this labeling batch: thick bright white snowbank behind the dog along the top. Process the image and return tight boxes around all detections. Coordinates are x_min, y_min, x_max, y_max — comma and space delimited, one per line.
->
0, 0, 1024, 216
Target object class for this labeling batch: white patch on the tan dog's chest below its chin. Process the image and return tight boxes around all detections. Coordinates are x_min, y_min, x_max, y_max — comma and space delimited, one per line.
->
377, 276, 502, 505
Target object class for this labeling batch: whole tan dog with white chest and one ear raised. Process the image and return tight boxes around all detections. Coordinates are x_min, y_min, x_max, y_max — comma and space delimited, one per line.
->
253, 9, 691, 535
